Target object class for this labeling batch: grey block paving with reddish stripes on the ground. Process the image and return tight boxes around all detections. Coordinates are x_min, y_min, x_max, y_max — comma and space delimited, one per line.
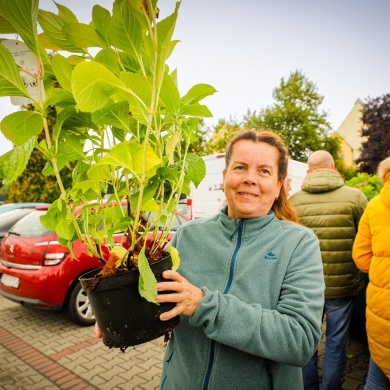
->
0, 296, 369, 390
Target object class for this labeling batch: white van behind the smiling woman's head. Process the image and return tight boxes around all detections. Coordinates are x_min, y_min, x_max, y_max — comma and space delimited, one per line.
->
187, 153, 307, 218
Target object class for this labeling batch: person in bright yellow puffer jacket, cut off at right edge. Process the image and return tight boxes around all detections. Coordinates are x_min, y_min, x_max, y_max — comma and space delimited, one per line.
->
352, 157, 390, 390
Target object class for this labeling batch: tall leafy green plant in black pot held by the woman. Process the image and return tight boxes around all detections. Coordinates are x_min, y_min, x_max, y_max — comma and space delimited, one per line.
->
0, 0, 215, 349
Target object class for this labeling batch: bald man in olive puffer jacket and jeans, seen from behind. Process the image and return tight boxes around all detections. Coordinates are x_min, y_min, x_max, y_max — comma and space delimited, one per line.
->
289, 150, 367, 390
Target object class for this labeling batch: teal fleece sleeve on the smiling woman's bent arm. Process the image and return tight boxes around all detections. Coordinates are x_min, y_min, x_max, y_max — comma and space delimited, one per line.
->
190, 232, 325, 366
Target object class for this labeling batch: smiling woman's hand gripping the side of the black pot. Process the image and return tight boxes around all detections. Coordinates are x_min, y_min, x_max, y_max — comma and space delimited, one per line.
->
156, 271, 203, 321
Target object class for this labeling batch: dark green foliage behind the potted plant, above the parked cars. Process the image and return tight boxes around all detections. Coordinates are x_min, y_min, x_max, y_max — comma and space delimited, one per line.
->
6, 105, 72, 203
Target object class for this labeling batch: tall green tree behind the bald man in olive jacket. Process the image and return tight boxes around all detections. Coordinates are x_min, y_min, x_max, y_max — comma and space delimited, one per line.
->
243, 71, 340, 162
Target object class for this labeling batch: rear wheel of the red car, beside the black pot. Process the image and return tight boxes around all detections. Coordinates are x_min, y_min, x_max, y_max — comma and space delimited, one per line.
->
65, 283, 95, 326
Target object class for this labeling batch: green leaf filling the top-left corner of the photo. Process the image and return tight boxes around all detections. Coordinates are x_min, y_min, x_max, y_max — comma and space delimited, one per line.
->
0, 0, 40, 57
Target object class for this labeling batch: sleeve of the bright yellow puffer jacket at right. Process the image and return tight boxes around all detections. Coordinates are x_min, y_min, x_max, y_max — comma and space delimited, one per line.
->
352, 211, 372, 273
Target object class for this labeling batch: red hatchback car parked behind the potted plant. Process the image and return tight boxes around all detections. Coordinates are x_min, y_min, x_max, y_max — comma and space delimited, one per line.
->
0, 206, 188, 326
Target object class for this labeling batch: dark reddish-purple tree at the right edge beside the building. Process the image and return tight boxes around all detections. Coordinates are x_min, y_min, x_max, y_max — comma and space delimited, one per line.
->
355, 93, 390, 174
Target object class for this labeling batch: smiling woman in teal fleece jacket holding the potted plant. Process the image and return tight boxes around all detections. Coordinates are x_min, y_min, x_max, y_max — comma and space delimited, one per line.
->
157, 131, 324, 390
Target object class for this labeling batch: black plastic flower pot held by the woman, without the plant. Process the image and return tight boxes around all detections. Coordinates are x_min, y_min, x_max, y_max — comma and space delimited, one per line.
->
79, 255, 180, 351
